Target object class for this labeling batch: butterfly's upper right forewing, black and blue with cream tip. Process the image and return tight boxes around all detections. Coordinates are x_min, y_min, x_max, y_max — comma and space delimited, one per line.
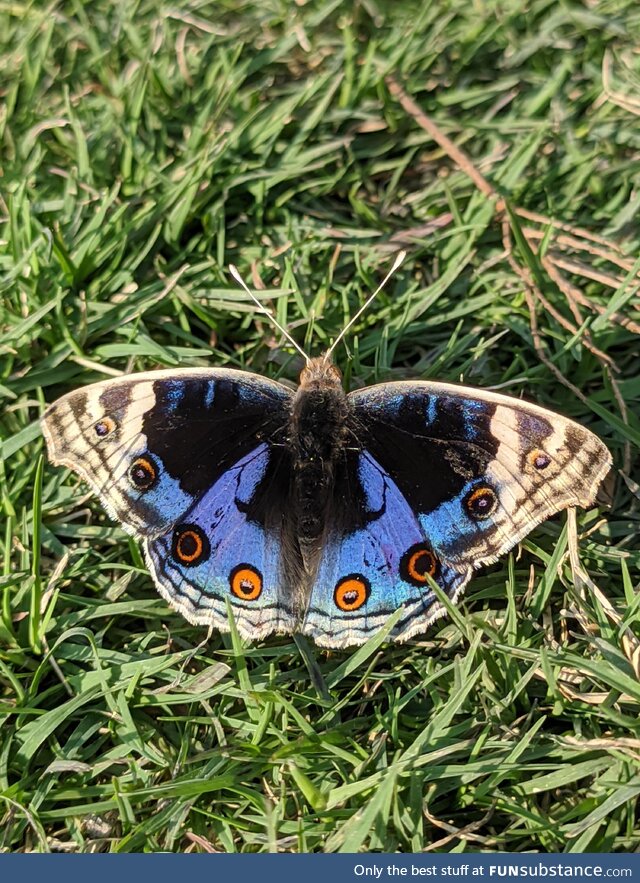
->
350, 382, 611, 567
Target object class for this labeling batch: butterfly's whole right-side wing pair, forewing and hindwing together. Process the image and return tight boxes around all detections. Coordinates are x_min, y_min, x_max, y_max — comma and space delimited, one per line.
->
304, 382, 611, 647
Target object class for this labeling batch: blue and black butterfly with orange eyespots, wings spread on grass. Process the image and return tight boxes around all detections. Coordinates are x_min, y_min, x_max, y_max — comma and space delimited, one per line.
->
42, 359, 611, 647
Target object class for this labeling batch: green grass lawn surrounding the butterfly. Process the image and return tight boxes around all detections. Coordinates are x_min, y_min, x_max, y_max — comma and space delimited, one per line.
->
0, 0, 640, 852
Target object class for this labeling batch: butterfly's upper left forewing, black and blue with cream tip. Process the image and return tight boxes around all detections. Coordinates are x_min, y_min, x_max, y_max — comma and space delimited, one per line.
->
42, 370, 291, 536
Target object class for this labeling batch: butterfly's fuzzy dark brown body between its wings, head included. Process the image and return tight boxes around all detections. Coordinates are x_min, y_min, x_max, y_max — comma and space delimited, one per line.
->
290, 356, 350, 570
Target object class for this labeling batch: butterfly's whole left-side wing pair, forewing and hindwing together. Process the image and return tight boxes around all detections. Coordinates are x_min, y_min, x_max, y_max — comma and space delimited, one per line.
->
42, 369, 298, 637
